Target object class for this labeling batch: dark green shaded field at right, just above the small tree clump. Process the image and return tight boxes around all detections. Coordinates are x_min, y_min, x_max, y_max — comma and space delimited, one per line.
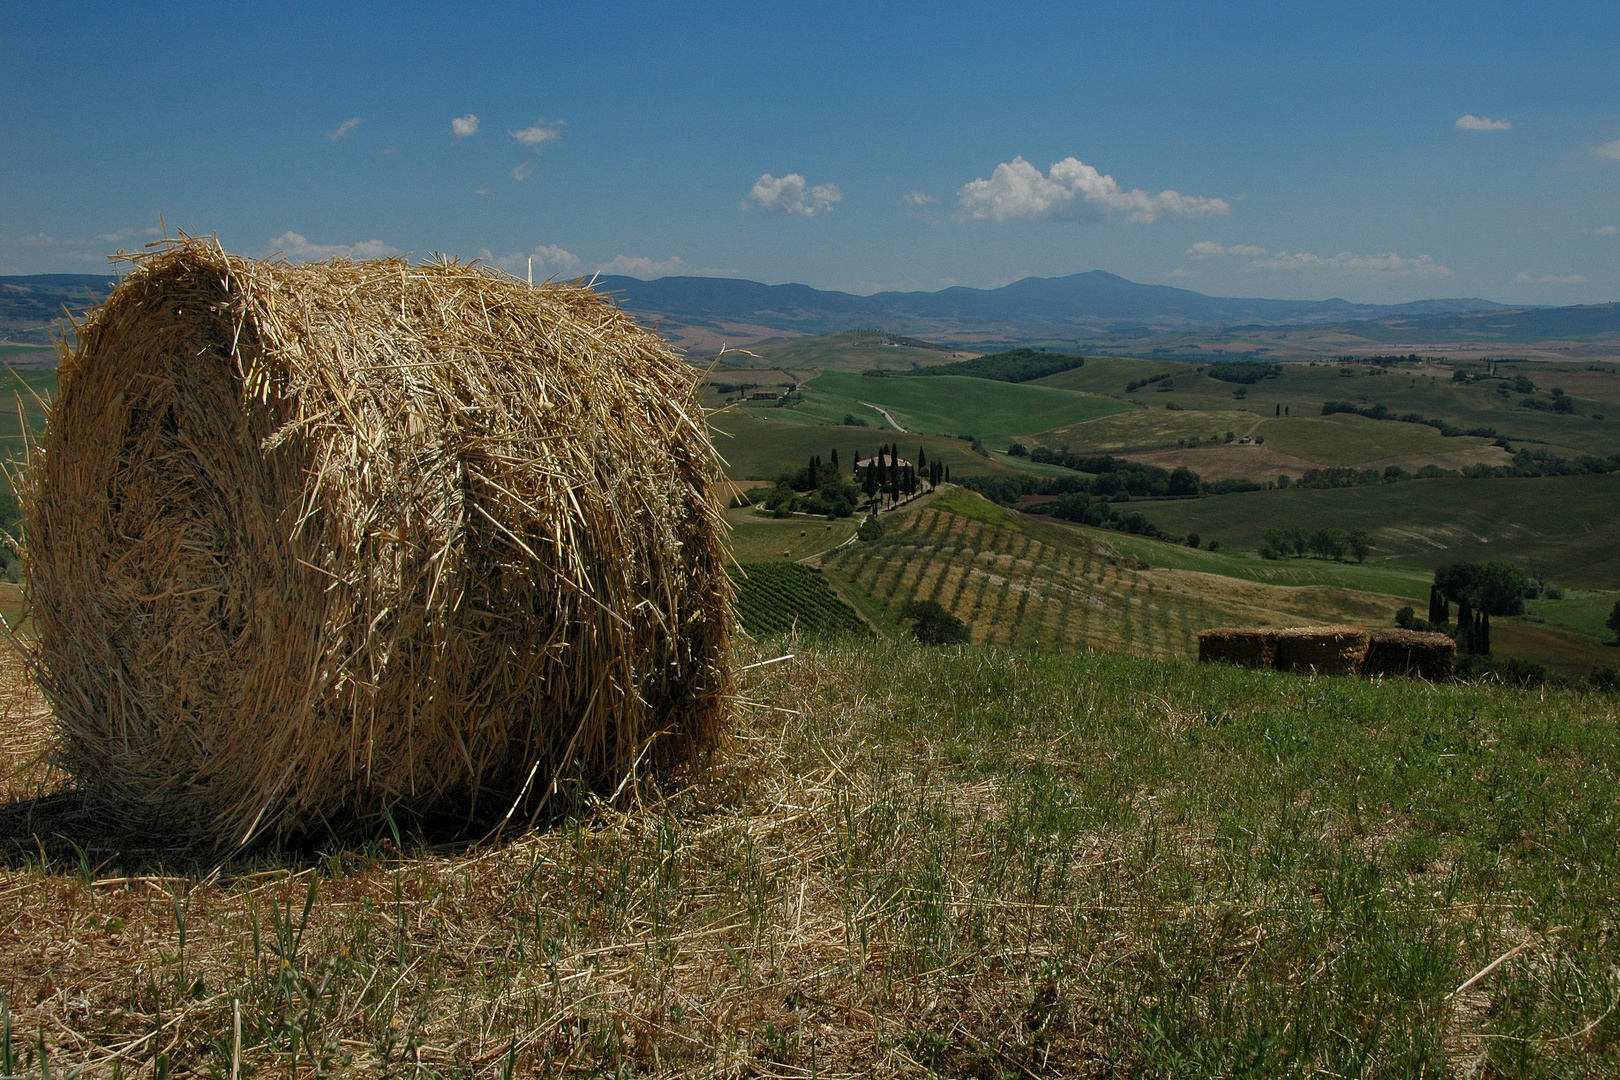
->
1139, 473, 1620, 589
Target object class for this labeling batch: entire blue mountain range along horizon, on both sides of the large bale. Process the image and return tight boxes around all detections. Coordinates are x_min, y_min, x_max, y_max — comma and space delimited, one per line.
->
0, 270, 1620, 355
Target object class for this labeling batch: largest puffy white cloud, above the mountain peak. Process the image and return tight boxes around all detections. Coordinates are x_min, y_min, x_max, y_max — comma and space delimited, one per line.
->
956, 157, 1231, 222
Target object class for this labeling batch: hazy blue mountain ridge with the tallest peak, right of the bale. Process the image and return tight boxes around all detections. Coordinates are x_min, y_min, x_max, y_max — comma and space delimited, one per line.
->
598, 270, 1507, 343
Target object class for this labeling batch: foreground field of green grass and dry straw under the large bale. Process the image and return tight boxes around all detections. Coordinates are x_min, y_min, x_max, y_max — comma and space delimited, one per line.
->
0, 641, 1620, 1077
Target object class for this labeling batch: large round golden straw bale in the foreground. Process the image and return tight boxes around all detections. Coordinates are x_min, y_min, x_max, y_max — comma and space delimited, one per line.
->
23, 241, 734, 845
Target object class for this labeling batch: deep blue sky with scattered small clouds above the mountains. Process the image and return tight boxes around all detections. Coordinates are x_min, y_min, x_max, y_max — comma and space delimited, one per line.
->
0, 0, 1620, 303
